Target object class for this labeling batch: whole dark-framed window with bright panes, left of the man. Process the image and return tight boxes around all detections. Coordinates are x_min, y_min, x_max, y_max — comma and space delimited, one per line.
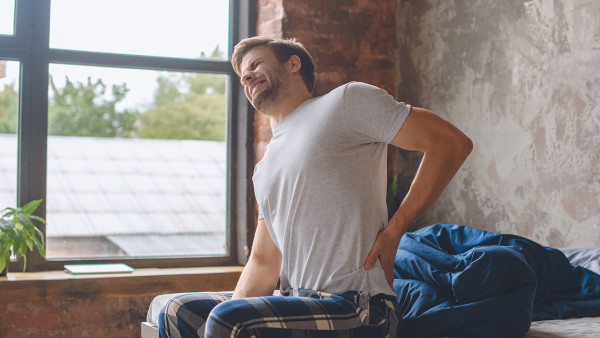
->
0, 0, 252, 271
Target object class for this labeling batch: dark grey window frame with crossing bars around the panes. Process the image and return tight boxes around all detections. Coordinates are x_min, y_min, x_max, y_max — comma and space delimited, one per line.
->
0, 0, 256, 271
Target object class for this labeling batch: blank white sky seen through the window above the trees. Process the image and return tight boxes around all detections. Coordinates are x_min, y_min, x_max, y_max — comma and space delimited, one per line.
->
0, 0, 229, 109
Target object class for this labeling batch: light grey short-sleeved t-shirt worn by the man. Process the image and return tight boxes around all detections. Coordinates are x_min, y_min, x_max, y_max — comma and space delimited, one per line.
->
253, 82, 410, 295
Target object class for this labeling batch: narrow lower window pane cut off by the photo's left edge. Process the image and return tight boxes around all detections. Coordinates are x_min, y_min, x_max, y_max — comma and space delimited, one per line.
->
0, 60, 20, 210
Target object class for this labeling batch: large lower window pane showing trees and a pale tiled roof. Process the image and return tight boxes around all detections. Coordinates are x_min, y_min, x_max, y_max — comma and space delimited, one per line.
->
46, 64, 227, 259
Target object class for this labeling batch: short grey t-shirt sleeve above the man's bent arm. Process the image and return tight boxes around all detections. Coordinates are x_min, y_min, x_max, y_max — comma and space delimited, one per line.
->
342, 82, 410, 143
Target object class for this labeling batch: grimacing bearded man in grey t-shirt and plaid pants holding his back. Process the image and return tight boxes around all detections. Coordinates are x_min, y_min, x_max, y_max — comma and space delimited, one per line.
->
159, 37, 472, 337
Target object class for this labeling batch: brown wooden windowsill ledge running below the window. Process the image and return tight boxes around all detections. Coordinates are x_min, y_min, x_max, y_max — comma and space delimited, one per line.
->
0, 266, 243, 304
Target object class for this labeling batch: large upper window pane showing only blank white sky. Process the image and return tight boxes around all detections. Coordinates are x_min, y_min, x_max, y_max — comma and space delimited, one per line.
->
50, 0, 229, 59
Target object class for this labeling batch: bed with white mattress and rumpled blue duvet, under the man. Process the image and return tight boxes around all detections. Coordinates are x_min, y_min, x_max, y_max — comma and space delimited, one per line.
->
142, 224, 600, 338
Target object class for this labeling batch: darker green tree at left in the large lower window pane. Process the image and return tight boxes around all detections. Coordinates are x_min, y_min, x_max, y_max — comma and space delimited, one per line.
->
48, 77, 138, 137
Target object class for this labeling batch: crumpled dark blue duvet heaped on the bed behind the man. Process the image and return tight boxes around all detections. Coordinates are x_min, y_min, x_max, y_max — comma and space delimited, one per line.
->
394, 224, 600, 337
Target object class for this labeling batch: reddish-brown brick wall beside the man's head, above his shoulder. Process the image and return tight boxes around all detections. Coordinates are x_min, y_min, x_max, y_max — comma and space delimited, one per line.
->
282, 0, 396, 95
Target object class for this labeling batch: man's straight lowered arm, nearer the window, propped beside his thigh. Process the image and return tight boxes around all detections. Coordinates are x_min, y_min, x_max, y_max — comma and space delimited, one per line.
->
232, 219, 281, 299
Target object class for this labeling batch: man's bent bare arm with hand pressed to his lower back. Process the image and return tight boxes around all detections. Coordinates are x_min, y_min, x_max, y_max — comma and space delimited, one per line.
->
365, 107, 473, 285
